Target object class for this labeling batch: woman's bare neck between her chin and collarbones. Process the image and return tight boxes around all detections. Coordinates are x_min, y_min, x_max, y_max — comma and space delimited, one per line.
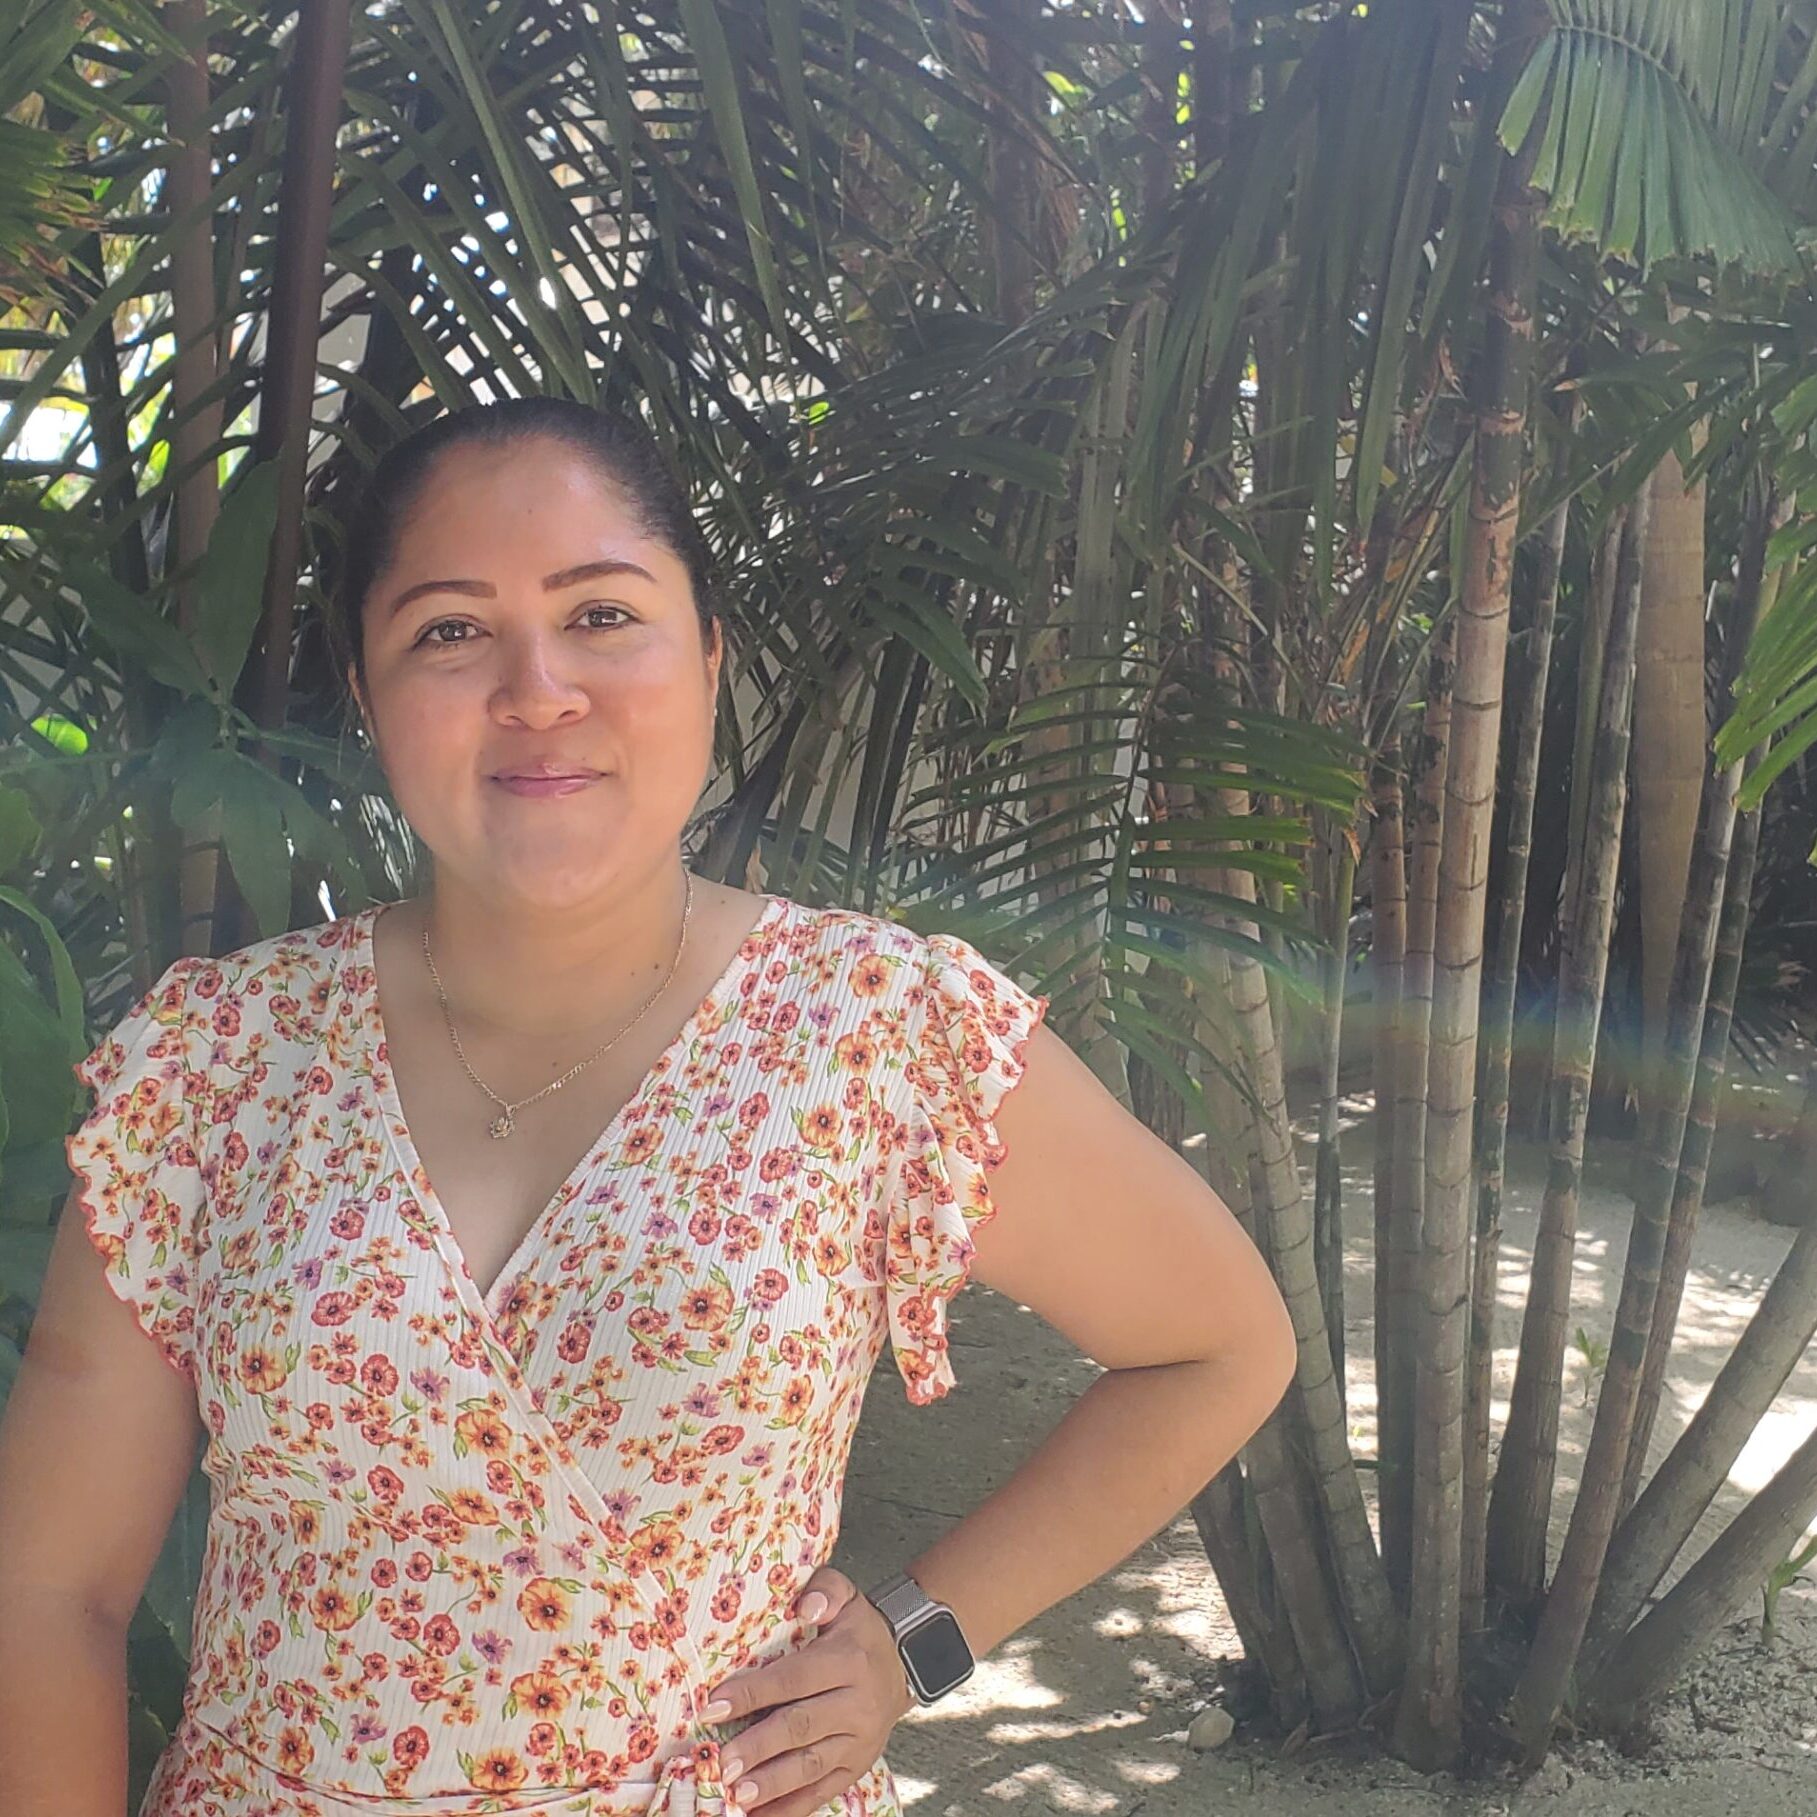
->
405, 856, 701, 1038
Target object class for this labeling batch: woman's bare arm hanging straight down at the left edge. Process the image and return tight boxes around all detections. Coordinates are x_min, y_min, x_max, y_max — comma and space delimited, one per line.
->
0, 1192, 204, 1817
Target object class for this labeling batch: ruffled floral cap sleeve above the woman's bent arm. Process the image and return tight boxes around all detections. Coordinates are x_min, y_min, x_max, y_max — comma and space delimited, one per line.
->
883, 934, 1048, 1406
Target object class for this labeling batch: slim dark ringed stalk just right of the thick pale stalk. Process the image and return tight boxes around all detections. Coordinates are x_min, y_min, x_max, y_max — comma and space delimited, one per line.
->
1463, 446, 1577, 1630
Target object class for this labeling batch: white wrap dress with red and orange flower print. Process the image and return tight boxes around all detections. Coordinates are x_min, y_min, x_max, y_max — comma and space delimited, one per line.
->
67, 896, 1047, 1817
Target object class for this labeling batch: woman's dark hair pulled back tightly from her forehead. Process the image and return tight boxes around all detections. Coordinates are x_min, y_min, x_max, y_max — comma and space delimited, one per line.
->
323, 398, 720, 697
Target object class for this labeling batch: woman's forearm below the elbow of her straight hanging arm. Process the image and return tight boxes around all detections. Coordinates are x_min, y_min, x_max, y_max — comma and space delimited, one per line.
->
0, 1592, 127, 1817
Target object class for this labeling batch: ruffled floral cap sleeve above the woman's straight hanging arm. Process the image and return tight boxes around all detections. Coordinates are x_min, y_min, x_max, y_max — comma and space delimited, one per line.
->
64, 956, 211, 1383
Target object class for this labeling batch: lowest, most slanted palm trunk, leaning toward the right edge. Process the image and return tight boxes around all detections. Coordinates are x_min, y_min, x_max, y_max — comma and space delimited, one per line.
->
1592, 1432, 1817, 1724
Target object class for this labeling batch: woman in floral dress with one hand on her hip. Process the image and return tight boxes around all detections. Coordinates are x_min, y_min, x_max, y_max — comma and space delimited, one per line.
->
0, 400, 1294, 1817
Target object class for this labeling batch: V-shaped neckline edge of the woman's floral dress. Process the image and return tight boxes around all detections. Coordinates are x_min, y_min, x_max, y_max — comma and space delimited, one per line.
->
356, 896, 789, 1335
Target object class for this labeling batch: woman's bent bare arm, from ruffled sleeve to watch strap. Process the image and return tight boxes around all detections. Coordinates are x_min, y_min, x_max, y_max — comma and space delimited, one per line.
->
907, 1025, 1296, 1655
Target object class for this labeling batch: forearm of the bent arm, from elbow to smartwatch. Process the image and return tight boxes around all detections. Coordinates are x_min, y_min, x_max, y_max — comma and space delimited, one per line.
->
907, 1359, 1279, 1659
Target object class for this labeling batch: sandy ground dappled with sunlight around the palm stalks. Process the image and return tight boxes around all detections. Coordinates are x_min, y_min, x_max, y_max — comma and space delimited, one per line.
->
834, 1127, 1817, 1817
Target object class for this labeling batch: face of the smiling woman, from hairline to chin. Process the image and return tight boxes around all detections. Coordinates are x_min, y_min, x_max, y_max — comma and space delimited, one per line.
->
350, 438, 721, 909
